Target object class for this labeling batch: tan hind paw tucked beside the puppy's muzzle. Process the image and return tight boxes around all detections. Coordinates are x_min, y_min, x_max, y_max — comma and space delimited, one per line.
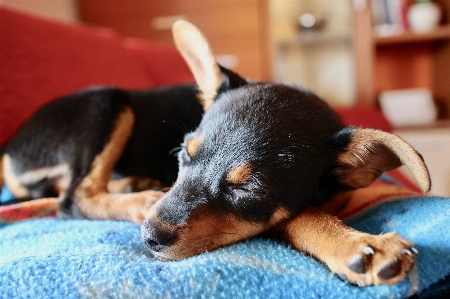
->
126, 190, 165, 224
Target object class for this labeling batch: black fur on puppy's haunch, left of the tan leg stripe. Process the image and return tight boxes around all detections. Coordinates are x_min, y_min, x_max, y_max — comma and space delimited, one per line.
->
5, 88, 128, 202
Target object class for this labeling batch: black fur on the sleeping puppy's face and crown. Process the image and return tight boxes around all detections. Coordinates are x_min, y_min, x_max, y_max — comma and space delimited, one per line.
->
142, 68, 351, 251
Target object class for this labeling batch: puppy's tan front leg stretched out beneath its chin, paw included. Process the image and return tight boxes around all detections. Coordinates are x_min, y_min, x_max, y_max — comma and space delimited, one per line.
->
271, 208, 415, 286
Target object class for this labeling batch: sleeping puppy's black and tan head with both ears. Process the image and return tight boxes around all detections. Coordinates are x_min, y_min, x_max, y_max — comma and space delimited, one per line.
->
142, 21, 430, 260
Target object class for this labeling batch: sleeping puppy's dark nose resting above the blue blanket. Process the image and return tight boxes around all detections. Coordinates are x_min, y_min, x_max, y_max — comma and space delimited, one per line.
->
141, 219, 176, 252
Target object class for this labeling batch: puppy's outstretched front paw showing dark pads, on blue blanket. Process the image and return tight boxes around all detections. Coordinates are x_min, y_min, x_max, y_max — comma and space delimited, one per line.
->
329, 233, 418, 286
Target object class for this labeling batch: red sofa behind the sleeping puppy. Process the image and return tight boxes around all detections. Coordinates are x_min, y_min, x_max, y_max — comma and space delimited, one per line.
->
0, 7, 415, 188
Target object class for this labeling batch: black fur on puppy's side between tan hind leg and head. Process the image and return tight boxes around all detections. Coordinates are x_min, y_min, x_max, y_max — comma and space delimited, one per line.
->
115, 84, 203, 186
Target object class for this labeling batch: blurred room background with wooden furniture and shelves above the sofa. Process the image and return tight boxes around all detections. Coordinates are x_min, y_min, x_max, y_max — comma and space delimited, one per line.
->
0, 0, 450, 195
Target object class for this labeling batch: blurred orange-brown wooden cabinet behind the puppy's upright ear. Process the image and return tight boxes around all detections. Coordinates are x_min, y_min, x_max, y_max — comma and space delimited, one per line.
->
79, 0, 272, 80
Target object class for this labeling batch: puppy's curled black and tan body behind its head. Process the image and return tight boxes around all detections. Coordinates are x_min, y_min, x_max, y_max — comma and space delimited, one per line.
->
0, 85, 203, 223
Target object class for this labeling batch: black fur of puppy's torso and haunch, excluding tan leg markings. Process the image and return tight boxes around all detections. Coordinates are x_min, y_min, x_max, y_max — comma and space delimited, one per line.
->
3, 85, 203, 210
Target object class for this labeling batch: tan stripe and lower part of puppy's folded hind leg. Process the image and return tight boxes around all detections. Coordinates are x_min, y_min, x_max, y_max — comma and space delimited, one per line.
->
60, 107, 164, 223
